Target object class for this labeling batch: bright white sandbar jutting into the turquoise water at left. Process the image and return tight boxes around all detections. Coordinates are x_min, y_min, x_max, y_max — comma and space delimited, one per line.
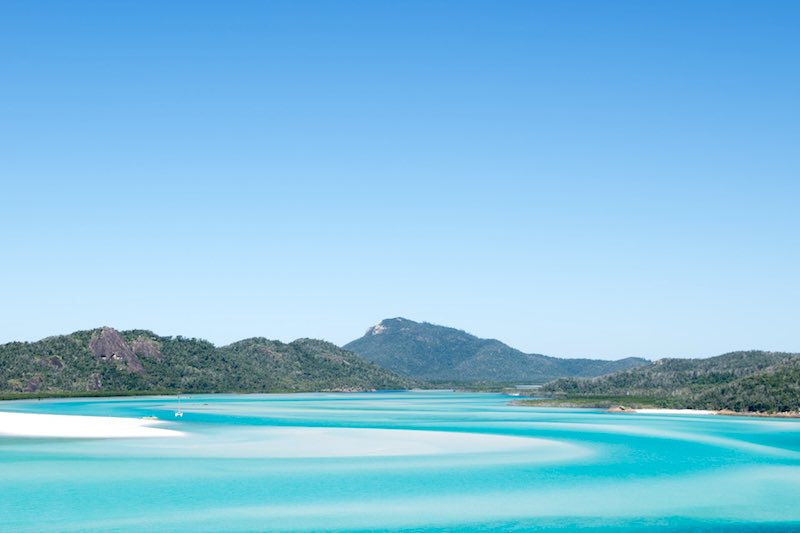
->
0, 411, 184, 439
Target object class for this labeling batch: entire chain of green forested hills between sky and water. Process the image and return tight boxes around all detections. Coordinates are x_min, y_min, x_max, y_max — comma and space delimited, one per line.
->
0, 318, 800, 412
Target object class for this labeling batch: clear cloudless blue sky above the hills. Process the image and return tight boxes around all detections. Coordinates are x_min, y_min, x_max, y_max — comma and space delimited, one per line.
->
0, 0, 800, 358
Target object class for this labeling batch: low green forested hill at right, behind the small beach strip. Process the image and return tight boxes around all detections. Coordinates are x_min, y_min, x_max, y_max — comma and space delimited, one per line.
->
542, 351, 800, 412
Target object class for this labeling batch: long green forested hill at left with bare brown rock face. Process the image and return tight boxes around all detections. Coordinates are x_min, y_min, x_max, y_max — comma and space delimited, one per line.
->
0, 328, 413, 394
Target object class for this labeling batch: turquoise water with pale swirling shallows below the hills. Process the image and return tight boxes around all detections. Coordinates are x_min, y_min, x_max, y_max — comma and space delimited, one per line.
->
0, 392, 800, 532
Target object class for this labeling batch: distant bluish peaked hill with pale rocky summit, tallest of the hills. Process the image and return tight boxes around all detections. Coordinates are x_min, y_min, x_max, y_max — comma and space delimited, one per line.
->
344, 318, 648, 383
